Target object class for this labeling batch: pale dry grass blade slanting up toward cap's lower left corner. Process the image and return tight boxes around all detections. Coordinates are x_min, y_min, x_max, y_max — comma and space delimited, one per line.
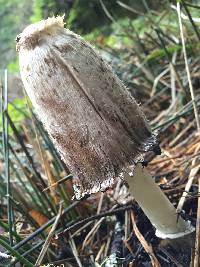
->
35, 203, 62, 266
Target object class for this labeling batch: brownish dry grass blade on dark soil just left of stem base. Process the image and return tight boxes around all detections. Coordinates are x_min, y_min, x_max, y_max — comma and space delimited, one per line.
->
131, 211, 161, 267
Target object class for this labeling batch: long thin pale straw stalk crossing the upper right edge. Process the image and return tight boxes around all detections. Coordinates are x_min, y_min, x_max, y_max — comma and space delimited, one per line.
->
177, 2, 200, 132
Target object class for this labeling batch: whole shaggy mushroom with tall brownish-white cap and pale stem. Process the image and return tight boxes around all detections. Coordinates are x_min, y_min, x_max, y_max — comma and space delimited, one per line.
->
16, 16, 194, 239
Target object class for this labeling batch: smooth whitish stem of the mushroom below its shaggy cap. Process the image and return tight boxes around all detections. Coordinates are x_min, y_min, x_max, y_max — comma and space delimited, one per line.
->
124, 164, 194, 239
